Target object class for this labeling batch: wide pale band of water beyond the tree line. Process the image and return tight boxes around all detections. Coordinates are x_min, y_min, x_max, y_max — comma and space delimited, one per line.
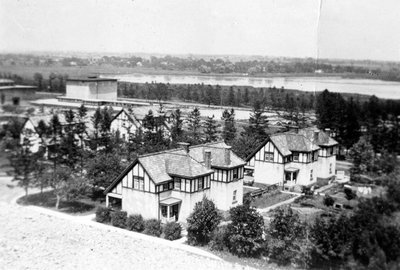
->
107, 73, 400, 99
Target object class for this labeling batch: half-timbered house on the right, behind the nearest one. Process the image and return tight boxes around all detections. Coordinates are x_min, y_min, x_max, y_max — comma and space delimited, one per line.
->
246, 128, 338, 188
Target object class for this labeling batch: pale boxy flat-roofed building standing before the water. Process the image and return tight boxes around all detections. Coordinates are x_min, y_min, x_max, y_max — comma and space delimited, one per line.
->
65, 76, 118, 100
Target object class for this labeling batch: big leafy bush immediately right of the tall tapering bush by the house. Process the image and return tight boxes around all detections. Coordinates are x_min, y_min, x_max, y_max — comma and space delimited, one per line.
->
227, 205, 264, 257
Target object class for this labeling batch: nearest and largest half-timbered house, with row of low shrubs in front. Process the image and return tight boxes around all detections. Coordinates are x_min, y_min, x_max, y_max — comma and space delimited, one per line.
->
105, 142, 246, 222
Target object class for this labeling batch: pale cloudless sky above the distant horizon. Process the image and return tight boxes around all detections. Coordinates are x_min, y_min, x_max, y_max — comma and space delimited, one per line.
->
0, 0, 400, 61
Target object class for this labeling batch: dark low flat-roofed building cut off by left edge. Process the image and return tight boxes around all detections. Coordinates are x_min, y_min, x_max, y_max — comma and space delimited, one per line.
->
0, 79, 36, 105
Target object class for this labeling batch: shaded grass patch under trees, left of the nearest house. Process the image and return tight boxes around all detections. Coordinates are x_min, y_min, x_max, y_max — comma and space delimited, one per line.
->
17, 191, 101, 215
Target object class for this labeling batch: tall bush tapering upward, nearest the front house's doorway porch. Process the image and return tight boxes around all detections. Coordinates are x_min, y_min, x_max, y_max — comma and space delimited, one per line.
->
187, 197, 222, 245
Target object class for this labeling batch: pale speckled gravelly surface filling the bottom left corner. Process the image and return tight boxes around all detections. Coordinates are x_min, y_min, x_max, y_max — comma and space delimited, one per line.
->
0, 178, 253, 270
